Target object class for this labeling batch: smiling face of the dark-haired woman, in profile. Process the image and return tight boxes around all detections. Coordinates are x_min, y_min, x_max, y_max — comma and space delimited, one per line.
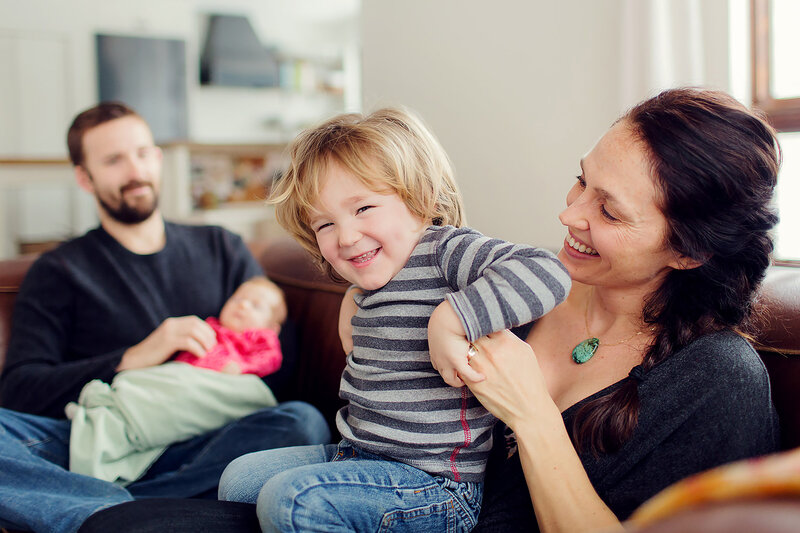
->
558, 122, 679, 292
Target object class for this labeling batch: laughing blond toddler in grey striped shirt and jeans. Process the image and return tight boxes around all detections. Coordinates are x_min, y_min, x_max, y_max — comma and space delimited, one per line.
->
220, 109, 570, 531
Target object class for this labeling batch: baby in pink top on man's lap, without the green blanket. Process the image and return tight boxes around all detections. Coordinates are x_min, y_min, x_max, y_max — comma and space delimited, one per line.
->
175, 278, 286, 377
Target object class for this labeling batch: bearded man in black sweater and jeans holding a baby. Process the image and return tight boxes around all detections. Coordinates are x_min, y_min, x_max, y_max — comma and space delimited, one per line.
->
0, 103, 330, 532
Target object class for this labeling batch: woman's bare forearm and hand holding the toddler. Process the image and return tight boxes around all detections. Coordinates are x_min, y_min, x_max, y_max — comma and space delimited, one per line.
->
465, 331, 624, 533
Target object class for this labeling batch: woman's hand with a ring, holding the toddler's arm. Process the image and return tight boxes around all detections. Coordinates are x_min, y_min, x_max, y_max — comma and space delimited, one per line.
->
464, 330, 560, 429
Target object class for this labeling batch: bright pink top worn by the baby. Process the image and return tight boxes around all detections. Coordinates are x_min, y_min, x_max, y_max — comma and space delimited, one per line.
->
175, 317, 283, 377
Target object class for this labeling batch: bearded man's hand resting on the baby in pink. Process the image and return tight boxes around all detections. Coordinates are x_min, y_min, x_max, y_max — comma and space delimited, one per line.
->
117, 316, 217, 371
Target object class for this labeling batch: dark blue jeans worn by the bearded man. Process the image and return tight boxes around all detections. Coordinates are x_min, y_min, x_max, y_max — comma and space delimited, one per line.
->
0, 402, 330, 533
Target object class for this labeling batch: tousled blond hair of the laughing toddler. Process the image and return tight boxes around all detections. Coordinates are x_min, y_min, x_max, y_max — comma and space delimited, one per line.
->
268, 108, 465, 277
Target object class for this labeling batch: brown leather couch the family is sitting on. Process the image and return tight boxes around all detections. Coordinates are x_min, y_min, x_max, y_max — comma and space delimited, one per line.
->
0, 238, 800, 528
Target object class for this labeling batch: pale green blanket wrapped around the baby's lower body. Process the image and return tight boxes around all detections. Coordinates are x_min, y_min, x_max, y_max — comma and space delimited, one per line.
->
66, 362, 277, 485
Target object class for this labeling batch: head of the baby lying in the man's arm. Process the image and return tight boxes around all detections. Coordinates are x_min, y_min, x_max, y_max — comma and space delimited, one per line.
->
219, 282, 284, 331
